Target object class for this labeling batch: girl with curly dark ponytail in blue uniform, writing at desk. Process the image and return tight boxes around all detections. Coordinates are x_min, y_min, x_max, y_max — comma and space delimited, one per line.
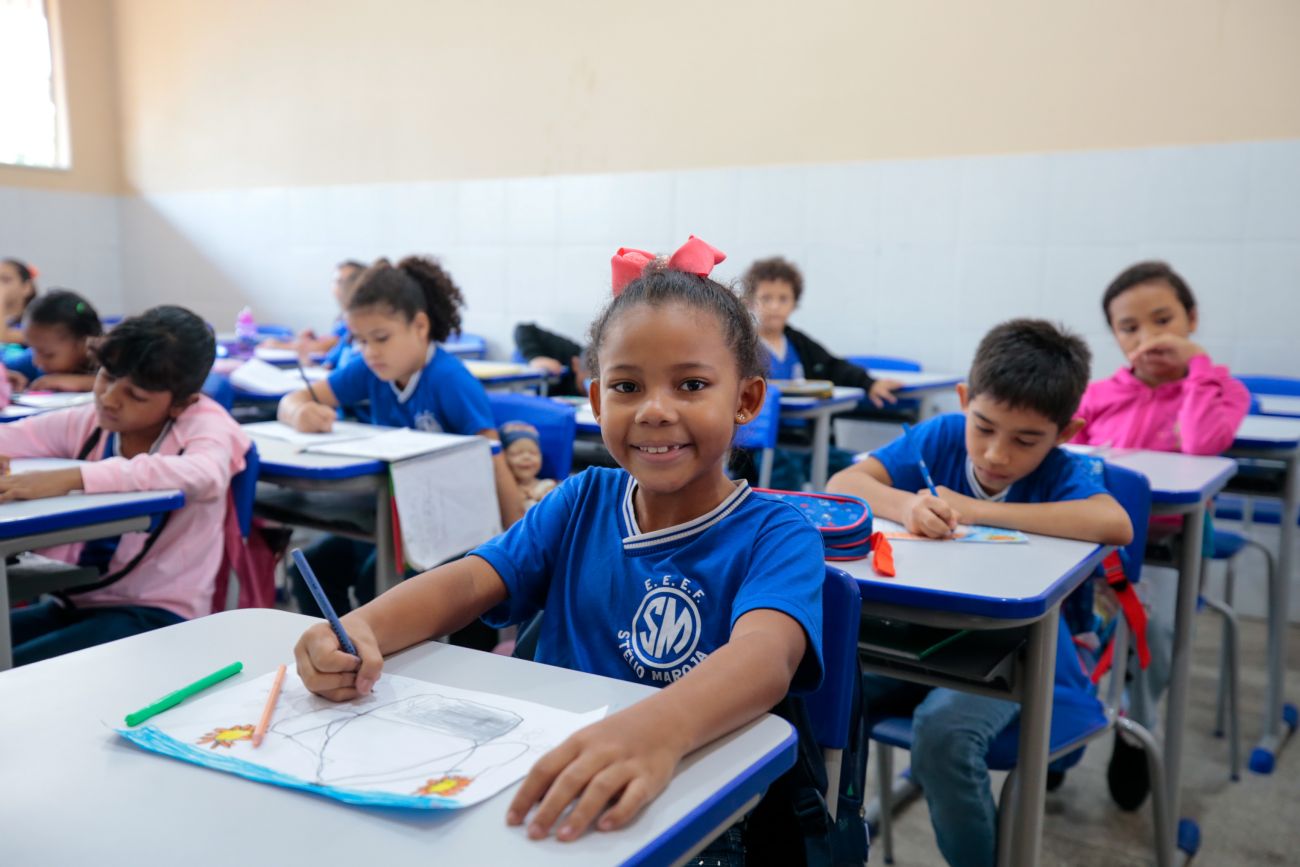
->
277, 256, 524, 623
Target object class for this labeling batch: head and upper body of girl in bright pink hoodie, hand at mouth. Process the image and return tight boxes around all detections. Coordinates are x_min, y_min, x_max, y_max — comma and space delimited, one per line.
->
1074, 261, 1251, 455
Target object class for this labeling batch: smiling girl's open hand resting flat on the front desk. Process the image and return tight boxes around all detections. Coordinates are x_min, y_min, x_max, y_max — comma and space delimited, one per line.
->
506, 706, 685, 842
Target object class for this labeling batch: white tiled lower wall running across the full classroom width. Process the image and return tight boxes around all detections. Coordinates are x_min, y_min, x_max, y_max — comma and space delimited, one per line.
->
0, 140, 1300, 623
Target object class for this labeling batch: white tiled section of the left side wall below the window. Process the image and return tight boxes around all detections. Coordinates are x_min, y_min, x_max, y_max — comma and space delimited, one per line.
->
0, 187, 124, 316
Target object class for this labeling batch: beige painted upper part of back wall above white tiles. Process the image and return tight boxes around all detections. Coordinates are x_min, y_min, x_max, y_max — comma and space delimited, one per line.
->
109, 0, 1300, 191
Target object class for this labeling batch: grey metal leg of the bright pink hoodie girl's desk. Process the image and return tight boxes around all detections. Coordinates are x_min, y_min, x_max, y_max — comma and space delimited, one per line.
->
1165, 502, 1205, 851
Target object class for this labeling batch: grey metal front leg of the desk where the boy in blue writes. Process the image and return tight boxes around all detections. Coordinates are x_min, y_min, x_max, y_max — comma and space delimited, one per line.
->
1009, 607, 1061, 867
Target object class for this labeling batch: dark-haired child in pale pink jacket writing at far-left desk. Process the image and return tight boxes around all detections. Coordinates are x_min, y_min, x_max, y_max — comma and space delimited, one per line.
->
0, 307, 250, 666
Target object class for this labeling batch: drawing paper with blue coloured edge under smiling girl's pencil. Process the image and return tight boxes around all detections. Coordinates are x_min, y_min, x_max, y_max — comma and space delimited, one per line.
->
117, 667, 607, 810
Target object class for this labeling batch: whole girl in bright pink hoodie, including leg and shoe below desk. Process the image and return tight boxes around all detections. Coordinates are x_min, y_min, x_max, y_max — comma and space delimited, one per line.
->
1074, 261, 1251, 810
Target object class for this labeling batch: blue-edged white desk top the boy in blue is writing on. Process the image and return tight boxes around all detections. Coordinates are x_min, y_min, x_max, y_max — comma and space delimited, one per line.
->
827, 517, 1109, 620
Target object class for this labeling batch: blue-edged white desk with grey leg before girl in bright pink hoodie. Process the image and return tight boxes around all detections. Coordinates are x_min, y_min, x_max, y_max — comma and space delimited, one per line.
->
1100, 450, 1236, 851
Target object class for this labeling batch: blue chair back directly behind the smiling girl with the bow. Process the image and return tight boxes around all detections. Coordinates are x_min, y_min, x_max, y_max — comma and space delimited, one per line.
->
803, 565, 862, 750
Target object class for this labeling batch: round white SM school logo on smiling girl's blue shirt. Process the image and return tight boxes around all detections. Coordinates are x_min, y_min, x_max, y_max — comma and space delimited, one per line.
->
619, 575, 709, 682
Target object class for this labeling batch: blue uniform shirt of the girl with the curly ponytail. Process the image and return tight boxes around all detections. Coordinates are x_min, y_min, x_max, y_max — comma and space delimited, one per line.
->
329, 344, 497, 434
